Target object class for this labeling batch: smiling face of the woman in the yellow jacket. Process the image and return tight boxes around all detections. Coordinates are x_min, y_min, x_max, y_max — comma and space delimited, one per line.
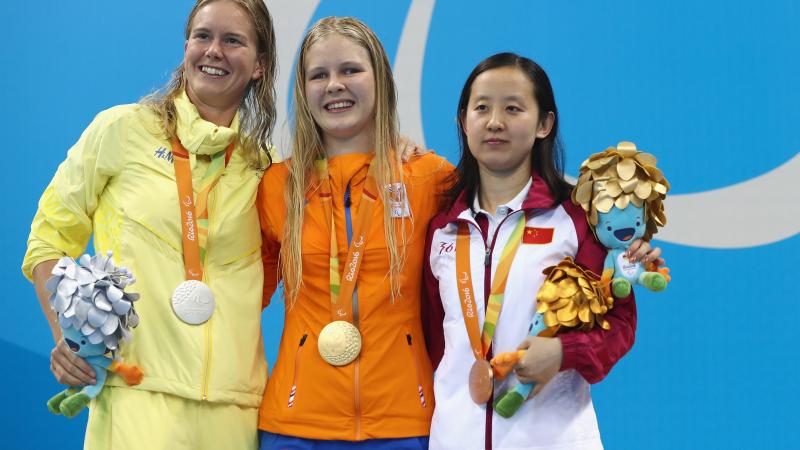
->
183, 0, 262, 120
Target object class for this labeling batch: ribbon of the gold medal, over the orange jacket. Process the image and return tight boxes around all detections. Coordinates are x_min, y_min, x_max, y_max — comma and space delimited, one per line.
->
315, 158, 378, 323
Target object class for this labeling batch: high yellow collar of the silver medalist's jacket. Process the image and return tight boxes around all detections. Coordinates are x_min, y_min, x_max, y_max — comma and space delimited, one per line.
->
175, 92, 239, 155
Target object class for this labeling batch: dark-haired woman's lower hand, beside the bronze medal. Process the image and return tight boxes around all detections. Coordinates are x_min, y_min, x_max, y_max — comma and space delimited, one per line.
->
514, 336, 563, 396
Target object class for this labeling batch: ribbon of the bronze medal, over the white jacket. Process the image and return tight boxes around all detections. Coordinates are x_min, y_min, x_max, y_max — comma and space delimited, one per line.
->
456, 213, 527, 359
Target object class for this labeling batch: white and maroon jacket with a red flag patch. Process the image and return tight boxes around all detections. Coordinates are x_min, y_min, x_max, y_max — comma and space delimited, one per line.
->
422, 174, 636, 450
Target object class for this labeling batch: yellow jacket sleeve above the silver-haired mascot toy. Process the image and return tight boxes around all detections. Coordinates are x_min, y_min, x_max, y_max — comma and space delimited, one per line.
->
22, 107, 124, 280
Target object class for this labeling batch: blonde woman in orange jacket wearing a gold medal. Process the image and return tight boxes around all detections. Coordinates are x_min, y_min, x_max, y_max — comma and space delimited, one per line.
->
257, 17, 453, 449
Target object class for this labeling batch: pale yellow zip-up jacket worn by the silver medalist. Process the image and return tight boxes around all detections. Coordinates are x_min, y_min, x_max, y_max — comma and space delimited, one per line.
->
22, 94, 267, 407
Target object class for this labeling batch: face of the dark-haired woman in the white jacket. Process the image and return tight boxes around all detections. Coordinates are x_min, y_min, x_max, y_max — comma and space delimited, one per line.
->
462, 67, 554, 174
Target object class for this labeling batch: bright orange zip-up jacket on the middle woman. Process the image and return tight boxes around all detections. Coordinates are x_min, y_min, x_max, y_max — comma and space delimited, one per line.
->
257, 153, 453, 441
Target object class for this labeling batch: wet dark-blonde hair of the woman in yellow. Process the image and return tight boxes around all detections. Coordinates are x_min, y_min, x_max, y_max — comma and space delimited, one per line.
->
140, 0, 278, 169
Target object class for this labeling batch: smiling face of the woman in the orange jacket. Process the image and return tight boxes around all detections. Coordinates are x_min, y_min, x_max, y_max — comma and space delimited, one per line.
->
304, 33, 375, 154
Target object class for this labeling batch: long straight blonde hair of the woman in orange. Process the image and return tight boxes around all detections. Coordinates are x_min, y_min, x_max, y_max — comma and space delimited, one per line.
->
281, 17, 405, 305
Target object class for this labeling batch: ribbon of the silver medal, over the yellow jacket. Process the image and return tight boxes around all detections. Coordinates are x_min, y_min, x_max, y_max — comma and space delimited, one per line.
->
172, 138, 234, 280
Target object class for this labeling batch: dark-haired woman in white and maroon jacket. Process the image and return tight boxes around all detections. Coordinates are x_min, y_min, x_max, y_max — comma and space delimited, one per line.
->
422, 53, 660, 450
